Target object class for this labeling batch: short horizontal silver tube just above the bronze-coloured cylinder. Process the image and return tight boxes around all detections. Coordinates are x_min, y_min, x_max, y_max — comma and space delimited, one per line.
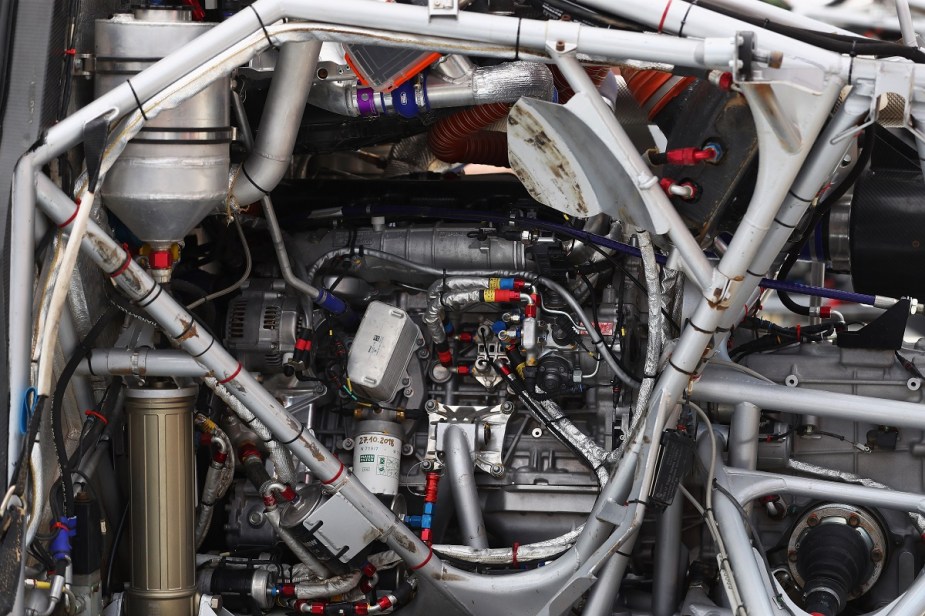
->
77, 349, 209, 377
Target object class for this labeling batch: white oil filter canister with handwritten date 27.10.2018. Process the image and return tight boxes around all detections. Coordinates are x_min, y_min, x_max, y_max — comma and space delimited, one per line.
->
353, 420, 402, 496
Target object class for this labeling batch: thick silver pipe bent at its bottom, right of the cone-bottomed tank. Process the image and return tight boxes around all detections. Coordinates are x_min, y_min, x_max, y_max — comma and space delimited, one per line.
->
231, 41, 321, 205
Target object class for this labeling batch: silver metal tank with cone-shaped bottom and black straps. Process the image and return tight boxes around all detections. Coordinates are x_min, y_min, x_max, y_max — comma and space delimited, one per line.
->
95, 8, 233, 249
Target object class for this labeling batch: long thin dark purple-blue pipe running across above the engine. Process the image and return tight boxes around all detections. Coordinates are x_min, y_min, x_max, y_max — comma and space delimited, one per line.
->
338, 205, 898, 308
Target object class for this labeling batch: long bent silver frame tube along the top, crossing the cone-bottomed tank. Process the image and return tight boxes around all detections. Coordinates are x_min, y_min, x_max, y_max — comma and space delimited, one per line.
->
23, 0, 736, 166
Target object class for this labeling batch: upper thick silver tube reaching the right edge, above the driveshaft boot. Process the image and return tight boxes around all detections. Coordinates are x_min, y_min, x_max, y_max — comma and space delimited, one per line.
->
691, 367, 925, 429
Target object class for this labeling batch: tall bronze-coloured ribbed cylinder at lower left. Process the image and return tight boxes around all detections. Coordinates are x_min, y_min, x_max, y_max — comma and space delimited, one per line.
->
125, 387, 197, 616
